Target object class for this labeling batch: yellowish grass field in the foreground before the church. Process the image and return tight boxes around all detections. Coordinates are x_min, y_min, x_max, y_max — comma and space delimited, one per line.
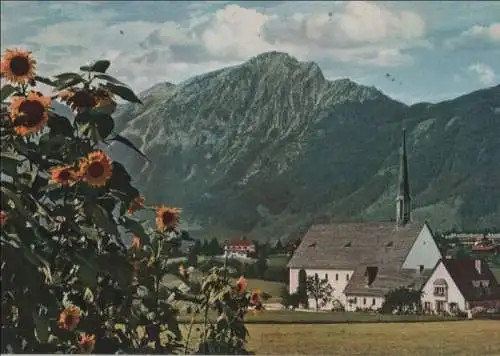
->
248, 320, 500, 356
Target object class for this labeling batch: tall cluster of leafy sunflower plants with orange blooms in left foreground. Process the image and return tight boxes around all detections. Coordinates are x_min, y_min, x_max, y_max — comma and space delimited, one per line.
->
0, 49, 261, 354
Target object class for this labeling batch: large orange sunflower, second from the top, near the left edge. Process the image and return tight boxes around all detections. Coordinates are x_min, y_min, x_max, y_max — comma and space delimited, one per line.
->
10, 90, 51, 136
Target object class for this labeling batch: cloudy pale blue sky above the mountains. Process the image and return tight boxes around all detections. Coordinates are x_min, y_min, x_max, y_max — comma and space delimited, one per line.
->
0, 1, 500, 104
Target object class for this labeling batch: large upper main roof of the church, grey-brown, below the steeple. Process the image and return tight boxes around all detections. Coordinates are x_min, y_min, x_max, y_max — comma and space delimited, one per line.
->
288, 222, 423, 273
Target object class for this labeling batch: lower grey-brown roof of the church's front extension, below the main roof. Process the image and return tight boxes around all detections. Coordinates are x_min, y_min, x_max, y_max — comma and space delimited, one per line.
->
344, 265, 432, 297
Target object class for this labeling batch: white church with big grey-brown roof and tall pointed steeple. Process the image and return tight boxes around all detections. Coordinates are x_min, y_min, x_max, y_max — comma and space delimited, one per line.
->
288, 130, 442, 311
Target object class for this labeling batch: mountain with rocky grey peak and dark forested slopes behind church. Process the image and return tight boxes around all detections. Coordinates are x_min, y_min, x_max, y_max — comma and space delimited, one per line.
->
111, 52, 500, 239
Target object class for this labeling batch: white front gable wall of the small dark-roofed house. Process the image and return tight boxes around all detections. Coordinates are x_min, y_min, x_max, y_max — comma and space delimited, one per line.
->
422, 262, 467, 311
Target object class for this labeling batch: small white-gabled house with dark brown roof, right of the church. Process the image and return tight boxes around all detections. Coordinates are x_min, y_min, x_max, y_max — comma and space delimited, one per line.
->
422, 259, 500, 313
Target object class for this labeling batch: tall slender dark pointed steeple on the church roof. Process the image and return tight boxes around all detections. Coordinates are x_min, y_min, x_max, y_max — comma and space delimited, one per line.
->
396, 129, 411, 226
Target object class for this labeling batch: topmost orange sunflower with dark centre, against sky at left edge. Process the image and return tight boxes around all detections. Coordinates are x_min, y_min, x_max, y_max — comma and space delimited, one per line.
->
0, 49, 36, 84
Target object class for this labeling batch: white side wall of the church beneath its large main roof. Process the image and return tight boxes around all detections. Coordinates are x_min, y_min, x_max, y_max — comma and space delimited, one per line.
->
289, 268, 354, 309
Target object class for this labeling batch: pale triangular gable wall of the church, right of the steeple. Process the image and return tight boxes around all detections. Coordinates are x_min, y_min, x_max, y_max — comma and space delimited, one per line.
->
403, 224, 441, 269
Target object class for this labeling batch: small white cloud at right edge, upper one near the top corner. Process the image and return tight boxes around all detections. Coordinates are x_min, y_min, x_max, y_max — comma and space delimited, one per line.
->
445, 22, 500, 49
